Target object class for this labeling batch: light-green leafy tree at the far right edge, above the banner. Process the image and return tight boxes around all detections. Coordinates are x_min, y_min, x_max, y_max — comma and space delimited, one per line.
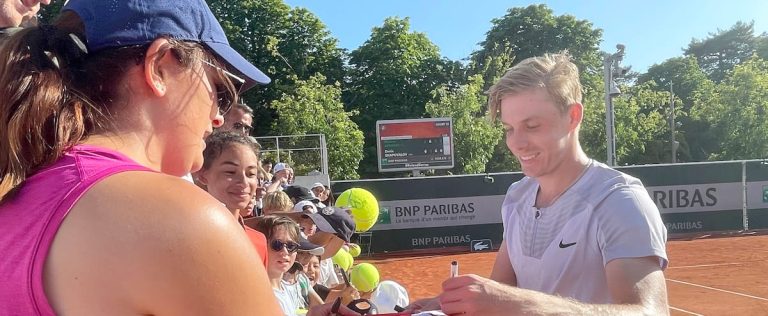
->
694, 57, 768, 160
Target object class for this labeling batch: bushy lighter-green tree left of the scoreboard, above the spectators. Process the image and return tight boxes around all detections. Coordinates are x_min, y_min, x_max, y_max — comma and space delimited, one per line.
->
272, 74, 363, 180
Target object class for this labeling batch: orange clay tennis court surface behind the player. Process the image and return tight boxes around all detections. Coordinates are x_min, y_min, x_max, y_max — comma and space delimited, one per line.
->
367, 235, 768, 315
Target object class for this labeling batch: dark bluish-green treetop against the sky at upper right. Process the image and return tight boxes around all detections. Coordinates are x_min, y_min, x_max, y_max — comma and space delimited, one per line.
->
685, 21, 759, 82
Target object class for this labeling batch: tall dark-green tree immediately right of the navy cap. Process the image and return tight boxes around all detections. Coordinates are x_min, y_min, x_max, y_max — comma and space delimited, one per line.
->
208, 0, 344, 135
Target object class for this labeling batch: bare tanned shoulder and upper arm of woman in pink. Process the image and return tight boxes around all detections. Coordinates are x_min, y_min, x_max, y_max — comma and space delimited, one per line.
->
46, 172, 268, 314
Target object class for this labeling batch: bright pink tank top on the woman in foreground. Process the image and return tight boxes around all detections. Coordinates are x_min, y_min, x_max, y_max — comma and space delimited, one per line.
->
0, 145, 152, 315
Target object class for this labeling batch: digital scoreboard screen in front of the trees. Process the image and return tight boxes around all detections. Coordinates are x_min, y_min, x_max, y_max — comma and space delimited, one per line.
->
376, 118, 453, 172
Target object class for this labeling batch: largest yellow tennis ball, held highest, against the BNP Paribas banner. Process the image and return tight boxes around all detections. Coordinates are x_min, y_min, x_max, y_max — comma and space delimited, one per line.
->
336, 188, 379, 233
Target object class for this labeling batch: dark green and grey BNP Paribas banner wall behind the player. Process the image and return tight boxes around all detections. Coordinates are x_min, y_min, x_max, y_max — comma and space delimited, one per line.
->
333, 162, 756, 252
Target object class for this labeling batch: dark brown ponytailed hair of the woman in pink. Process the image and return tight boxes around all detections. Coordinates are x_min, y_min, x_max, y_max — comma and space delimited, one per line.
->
0, 11, 237, 199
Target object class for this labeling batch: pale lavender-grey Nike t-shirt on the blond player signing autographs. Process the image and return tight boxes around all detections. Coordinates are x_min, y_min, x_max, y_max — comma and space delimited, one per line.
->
502, 162, 668, 303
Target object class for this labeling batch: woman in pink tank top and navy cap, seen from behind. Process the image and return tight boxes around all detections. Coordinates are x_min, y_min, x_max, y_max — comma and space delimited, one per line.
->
0, 0, 292, 315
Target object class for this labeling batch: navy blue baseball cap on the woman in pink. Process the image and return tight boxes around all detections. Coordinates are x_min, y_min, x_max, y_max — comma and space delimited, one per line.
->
62, 0, 271, 92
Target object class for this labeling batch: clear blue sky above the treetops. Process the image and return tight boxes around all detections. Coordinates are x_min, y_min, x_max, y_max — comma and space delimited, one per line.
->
286, 0, 768, 72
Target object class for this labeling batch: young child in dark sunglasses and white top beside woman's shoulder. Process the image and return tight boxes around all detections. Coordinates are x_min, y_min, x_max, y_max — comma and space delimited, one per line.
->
249, 215, 303, 316
